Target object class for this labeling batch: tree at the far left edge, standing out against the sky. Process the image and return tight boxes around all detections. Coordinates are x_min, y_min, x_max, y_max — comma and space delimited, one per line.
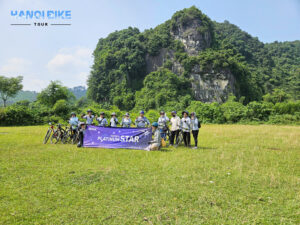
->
0, 76, 23, 107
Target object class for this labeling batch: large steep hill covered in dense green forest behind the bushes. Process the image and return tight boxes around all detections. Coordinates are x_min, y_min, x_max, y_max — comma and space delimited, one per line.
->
88, 7, 300, 110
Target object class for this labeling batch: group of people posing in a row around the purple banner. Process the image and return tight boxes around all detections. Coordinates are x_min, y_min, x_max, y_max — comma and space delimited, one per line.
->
69, 110, 201, 150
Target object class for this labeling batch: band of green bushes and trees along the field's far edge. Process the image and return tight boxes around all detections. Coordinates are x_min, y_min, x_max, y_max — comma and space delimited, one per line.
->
0, 79, 300, 126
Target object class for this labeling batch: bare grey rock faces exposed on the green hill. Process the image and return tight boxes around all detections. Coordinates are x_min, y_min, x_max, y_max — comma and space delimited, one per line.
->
146, 20, 236, 102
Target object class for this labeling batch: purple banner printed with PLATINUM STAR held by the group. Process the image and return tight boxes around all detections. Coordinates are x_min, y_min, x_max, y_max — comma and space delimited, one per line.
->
83, 125, 152, 150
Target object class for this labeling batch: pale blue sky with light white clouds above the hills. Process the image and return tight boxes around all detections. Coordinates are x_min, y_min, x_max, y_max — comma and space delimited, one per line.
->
0, 0, 300, 91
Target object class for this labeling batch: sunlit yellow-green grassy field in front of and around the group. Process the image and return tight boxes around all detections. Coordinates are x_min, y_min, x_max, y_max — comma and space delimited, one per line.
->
0, 125, 300, 224
